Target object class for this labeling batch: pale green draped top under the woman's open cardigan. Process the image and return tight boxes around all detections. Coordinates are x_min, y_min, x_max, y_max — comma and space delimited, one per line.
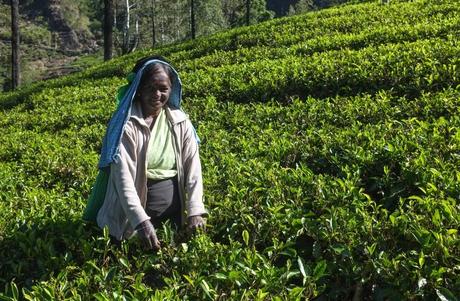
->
147, 109, 177, 180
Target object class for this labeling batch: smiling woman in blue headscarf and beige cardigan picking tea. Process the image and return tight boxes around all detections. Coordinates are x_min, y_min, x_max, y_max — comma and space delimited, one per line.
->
97, 57, 207, 250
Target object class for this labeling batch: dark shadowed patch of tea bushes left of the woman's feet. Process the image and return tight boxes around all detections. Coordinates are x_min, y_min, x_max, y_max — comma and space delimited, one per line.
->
0, 220, 101, 288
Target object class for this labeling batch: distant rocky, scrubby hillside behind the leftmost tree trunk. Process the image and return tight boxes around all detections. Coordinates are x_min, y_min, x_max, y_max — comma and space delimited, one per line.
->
0, 1, 100, 90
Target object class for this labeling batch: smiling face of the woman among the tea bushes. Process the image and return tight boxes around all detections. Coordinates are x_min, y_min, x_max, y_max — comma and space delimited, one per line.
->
139, 67, 171, 117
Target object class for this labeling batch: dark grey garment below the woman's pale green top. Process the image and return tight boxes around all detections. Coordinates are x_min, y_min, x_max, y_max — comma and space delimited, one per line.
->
145, 177, 181, 228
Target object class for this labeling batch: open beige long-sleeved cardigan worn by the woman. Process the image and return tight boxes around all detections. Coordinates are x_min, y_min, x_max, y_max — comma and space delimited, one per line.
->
97, 103, 207, 240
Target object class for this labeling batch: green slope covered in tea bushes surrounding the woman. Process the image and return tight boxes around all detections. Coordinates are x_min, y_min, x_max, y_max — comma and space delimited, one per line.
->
0, 0, 460, 300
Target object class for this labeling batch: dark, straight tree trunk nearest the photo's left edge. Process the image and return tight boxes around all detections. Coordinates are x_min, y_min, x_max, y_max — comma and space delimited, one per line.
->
11, 0, 21, 90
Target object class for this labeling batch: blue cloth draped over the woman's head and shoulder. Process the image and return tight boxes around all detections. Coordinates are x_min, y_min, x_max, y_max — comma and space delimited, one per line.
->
98, 59, 194, 169
